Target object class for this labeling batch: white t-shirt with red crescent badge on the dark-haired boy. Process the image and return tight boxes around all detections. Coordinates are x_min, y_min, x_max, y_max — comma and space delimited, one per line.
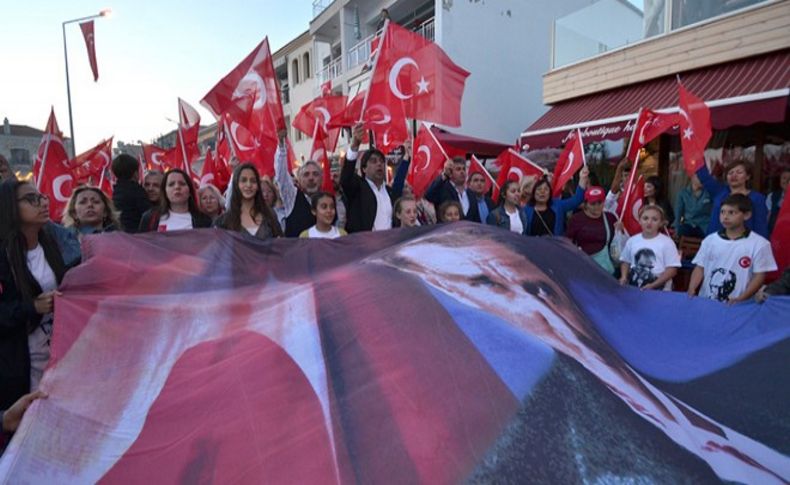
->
692, 231, 776, 301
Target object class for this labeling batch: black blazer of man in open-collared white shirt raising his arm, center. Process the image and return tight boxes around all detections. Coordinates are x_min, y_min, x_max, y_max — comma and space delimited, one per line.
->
340, 152, 400, 234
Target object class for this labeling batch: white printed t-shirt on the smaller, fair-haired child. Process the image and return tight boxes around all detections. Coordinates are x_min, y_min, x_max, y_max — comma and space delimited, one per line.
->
620, 233, 680, 291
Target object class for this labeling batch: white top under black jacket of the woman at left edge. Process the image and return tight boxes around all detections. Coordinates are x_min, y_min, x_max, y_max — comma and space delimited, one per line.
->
27, 244, 58, 392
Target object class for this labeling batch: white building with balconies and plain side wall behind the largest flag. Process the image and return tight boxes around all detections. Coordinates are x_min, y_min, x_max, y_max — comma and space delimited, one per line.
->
310, 0, 592, 144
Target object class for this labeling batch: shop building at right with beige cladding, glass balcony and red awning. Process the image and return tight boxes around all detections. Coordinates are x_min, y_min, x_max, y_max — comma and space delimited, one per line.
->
522, 0, 790, 200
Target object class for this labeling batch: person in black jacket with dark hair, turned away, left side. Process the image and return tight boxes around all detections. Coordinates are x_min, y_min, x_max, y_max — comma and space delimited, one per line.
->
112, 153, 151, 233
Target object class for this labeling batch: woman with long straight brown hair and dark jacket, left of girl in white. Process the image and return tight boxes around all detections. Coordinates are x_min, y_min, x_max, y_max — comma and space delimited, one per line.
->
214, 163, 283, 239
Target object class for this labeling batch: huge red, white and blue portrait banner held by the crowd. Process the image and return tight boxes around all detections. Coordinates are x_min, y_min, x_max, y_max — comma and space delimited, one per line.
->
0, 223, 790, 484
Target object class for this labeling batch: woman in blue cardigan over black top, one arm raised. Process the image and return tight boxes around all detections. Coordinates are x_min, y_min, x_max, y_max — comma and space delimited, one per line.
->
524, 167, 590, 236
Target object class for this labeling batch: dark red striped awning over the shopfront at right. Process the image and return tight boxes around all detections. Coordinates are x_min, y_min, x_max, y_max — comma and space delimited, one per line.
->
521, 49, 790, 149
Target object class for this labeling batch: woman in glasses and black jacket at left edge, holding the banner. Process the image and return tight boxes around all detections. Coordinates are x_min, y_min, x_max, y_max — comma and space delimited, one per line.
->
0, 179, 66, 409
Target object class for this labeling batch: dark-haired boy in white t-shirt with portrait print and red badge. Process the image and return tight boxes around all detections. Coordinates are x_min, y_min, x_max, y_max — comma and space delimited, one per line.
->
688, 194, 776, 303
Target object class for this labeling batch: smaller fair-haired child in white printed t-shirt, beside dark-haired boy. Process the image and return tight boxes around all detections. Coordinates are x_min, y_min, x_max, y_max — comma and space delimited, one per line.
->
620, 204, 680, 291
